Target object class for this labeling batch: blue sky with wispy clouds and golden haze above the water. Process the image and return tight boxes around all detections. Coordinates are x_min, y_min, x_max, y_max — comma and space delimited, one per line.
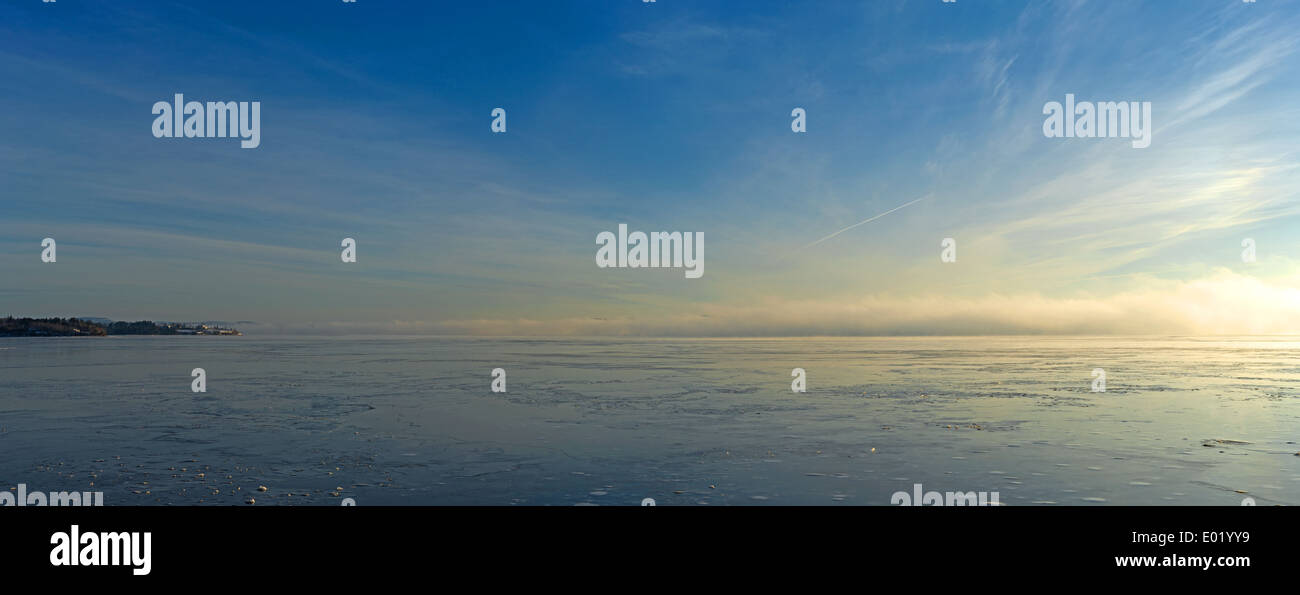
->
0, 0, 1300, 336
